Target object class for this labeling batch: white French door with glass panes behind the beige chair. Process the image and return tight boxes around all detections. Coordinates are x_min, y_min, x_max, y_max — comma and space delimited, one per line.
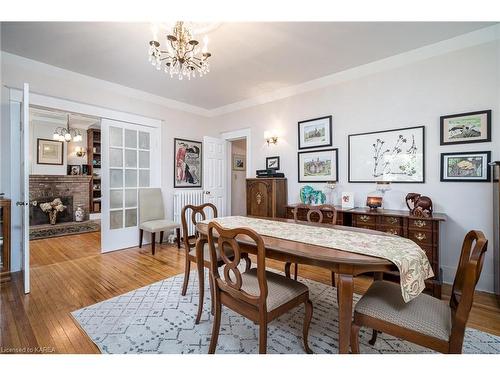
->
101, 119, 161, 253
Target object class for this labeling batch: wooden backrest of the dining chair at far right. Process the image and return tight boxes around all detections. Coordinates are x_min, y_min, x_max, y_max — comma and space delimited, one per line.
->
450, 230, 488, 346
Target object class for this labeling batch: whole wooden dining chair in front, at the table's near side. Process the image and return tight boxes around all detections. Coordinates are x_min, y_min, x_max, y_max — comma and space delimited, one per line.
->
208, 222, 313, 354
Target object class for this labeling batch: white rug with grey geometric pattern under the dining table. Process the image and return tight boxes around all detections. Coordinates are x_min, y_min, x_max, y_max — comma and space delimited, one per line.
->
72, 272, 500, 354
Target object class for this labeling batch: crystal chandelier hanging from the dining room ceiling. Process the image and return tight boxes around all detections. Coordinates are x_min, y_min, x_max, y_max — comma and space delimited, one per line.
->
149, 22, 212, 80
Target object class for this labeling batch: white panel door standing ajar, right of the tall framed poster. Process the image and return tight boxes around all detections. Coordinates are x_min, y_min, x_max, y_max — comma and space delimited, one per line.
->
203, 137, 227, 216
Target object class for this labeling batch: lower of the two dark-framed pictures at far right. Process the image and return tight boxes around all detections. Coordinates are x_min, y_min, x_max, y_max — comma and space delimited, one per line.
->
441, 151, 491, 182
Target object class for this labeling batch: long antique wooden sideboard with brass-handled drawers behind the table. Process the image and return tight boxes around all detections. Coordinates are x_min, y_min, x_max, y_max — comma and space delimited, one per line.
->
286, 205, 446, 298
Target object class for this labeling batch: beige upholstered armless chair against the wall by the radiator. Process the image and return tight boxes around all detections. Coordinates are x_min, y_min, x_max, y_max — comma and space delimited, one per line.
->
139, 188, 181, 255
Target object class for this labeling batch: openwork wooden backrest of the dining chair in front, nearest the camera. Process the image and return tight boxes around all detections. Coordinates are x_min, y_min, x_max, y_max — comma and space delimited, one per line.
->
208, 221, 267, 311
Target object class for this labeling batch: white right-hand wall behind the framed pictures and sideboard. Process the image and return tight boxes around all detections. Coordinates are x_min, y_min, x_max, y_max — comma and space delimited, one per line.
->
211, 41, 500, 291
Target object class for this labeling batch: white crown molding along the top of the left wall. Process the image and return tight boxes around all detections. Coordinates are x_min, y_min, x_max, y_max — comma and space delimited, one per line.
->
1, 51, 208, 117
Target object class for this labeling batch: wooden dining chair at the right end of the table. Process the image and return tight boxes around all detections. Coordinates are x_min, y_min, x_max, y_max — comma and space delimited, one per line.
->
351, 230, 488, 354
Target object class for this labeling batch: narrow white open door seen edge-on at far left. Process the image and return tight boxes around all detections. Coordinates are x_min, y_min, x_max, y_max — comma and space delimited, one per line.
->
17, 83, 30, 294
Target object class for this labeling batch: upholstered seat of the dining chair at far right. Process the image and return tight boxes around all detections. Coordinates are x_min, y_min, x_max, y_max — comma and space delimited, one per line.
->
354, 281, 451, 341
